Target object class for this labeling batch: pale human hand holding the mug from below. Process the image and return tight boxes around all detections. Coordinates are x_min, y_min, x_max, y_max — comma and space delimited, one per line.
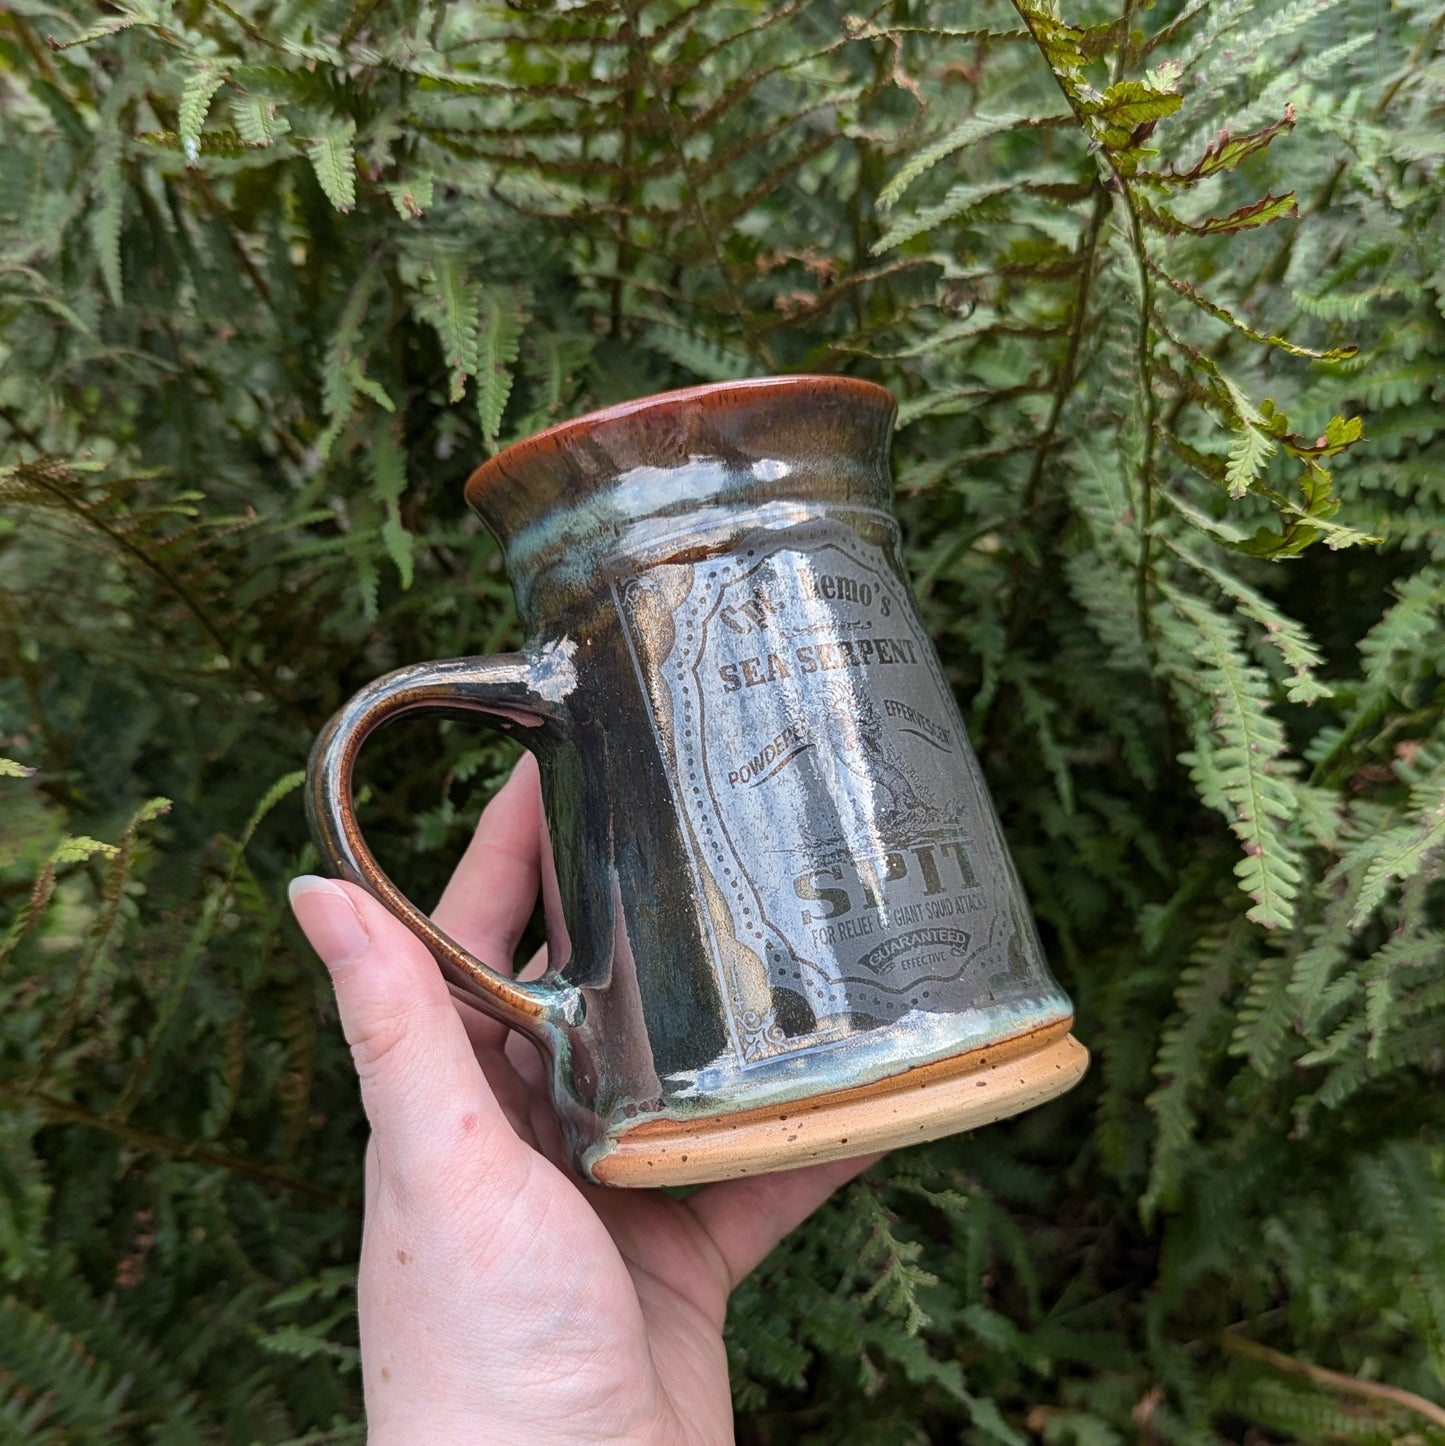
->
283, 755, 871, 1446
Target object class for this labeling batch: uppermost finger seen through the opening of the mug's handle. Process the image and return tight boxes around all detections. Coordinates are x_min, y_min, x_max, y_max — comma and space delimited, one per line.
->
431, 753, 542, 975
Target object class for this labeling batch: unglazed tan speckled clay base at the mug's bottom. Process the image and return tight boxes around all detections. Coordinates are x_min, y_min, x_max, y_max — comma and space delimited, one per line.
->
592, 1021, 1089, 1186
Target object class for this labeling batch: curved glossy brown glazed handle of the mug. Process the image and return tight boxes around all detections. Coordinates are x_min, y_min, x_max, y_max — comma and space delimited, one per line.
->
307, 648, 581, 1043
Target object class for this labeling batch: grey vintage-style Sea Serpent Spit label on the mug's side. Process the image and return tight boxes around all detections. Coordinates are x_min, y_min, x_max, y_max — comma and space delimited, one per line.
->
618, 522, 1043, 1064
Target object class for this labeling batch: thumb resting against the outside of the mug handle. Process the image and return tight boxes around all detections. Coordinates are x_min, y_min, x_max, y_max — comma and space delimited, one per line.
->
291, 875, 522, 1186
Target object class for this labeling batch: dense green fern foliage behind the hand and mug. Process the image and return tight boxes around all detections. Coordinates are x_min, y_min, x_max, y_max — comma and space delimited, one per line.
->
0, 0, 1445, 1446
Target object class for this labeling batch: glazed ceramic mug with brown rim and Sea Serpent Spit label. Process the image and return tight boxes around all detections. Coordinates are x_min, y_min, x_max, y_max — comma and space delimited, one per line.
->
307, 376, 1088, 1186
